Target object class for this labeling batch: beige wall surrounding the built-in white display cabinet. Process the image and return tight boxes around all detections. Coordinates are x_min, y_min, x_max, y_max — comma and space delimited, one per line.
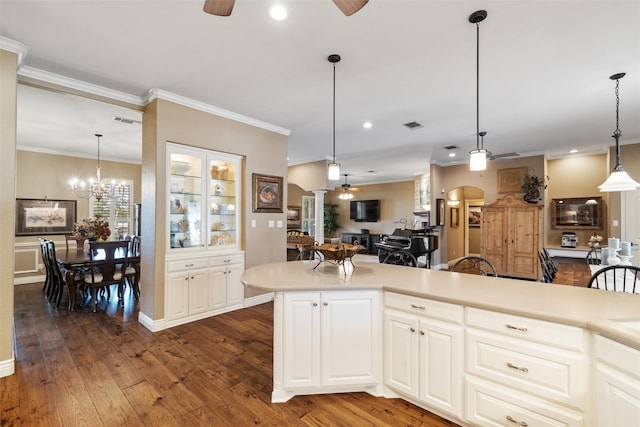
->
140, 100, 287, 319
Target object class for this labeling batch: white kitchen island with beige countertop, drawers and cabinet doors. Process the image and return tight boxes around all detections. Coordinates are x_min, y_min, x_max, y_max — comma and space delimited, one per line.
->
242, 261, 640, 426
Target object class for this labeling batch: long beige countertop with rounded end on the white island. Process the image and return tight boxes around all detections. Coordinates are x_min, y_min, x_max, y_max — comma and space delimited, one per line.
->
242, 261, 640, 349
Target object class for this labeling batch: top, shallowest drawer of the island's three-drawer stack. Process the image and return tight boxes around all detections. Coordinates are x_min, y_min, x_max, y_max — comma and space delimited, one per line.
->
466, 308, 585, 351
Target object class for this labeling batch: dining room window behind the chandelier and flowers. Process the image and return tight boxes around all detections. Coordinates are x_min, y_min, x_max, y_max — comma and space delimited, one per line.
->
89, 179, 135, 238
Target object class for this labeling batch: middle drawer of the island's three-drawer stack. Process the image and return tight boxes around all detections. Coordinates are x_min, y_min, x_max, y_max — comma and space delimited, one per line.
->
467, 329, 588, 409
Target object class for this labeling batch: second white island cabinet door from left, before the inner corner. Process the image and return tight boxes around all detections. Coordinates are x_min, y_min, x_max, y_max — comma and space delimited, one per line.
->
321, 291, 379, 386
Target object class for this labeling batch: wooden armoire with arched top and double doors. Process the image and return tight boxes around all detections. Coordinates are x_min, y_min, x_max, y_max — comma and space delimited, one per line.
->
480, 193, 544, 280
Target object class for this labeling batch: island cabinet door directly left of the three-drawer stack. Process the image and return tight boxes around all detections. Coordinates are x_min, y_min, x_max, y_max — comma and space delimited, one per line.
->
419, 319, 464, 415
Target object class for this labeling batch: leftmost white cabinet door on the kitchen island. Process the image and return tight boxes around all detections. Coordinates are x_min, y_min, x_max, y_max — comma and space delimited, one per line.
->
283, 292, 320, 388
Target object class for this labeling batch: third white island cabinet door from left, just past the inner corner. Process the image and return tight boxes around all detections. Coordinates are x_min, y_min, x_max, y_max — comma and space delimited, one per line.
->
384, 310, 419, 397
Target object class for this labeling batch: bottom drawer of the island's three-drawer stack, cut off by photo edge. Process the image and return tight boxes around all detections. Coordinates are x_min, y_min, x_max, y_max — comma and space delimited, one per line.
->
466, 377, 584, 427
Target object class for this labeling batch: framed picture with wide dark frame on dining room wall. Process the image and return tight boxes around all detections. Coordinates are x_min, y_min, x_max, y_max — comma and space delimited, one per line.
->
16, 199, 76, 236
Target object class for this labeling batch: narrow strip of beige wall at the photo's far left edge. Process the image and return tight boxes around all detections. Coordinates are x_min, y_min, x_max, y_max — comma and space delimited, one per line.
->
0, 49, 18, 376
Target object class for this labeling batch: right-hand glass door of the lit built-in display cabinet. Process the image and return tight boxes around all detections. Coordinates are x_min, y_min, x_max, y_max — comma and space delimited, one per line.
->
208, 154, 239, 249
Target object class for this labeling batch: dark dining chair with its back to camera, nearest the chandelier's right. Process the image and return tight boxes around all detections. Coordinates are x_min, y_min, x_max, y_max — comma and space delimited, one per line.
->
84, 240, 129, 313
